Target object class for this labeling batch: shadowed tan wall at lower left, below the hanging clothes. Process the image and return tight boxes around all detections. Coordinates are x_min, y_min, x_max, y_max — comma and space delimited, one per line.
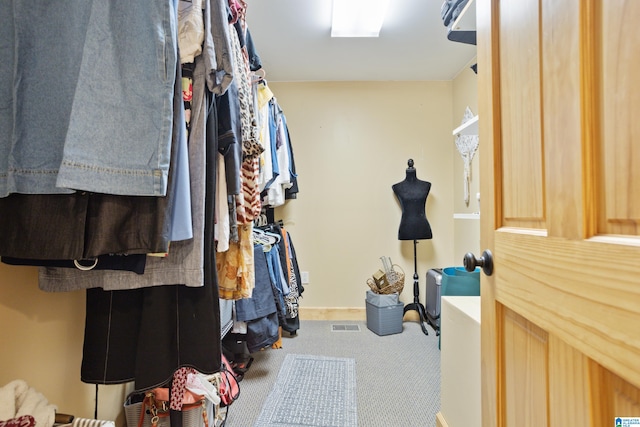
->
0, 263, 128, 425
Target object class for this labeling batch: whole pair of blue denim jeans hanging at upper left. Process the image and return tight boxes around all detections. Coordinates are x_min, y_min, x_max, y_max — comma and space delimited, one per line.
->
0, 0, 177, 197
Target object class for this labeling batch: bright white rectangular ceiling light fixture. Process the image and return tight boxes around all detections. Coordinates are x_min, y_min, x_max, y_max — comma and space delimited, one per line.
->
331, 0, 389, 37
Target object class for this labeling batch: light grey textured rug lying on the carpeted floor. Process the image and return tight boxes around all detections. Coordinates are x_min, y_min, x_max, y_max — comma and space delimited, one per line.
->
254, 354, 358, 427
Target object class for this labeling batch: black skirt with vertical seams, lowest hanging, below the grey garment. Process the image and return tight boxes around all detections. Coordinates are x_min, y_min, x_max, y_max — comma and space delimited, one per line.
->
80, 286, 220, 390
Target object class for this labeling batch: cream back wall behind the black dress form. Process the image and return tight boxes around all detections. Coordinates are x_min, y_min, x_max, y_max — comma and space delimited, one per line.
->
270, 81, 454, 309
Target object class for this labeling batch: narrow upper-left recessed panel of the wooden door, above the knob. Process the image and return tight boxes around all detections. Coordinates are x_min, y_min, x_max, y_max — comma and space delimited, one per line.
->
500, 0, 544, 228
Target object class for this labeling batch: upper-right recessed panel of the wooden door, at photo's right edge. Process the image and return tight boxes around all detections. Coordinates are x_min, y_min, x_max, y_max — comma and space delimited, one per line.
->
596, 0, 640, 236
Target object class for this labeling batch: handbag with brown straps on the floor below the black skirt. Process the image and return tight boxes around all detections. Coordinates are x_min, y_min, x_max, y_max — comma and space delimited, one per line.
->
124, 387, 215, 427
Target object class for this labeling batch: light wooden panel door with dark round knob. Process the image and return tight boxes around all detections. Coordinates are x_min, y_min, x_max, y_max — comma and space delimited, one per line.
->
476, 0, 640, 427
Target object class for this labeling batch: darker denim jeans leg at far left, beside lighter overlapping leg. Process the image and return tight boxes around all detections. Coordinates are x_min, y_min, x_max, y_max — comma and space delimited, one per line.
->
0, 0, 91, 197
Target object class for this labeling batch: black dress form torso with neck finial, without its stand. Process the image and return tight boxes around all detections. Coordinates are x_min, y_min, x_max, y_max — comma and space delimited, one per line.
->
391, 159, 433, 240
